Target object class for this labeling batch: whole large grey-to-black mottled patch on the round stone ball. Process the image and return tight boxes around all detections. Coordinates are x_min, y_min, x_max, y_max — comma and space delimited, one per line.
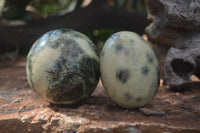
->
44, 39, 100, 102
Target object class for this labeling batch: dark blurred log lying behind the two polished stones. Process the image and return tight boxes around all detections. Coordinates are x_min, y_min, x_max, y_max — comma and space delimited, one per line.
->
0, 0, 149, 53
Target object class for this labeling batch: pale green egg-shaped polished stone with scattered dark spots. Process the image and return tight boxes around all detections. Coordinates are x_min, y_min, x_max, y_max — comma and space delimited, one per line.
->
100, 31, 160, 108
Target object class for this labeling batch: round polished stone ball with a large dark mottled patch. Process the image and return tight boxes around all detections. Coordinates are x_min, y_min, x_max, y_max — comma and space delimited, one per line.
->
26, 29, 100, 104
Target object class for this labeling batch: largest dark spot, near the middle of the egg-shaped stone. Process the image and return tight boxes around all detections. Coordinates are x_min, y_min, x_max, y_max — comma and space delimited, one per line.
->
116, 68, 131, 84
